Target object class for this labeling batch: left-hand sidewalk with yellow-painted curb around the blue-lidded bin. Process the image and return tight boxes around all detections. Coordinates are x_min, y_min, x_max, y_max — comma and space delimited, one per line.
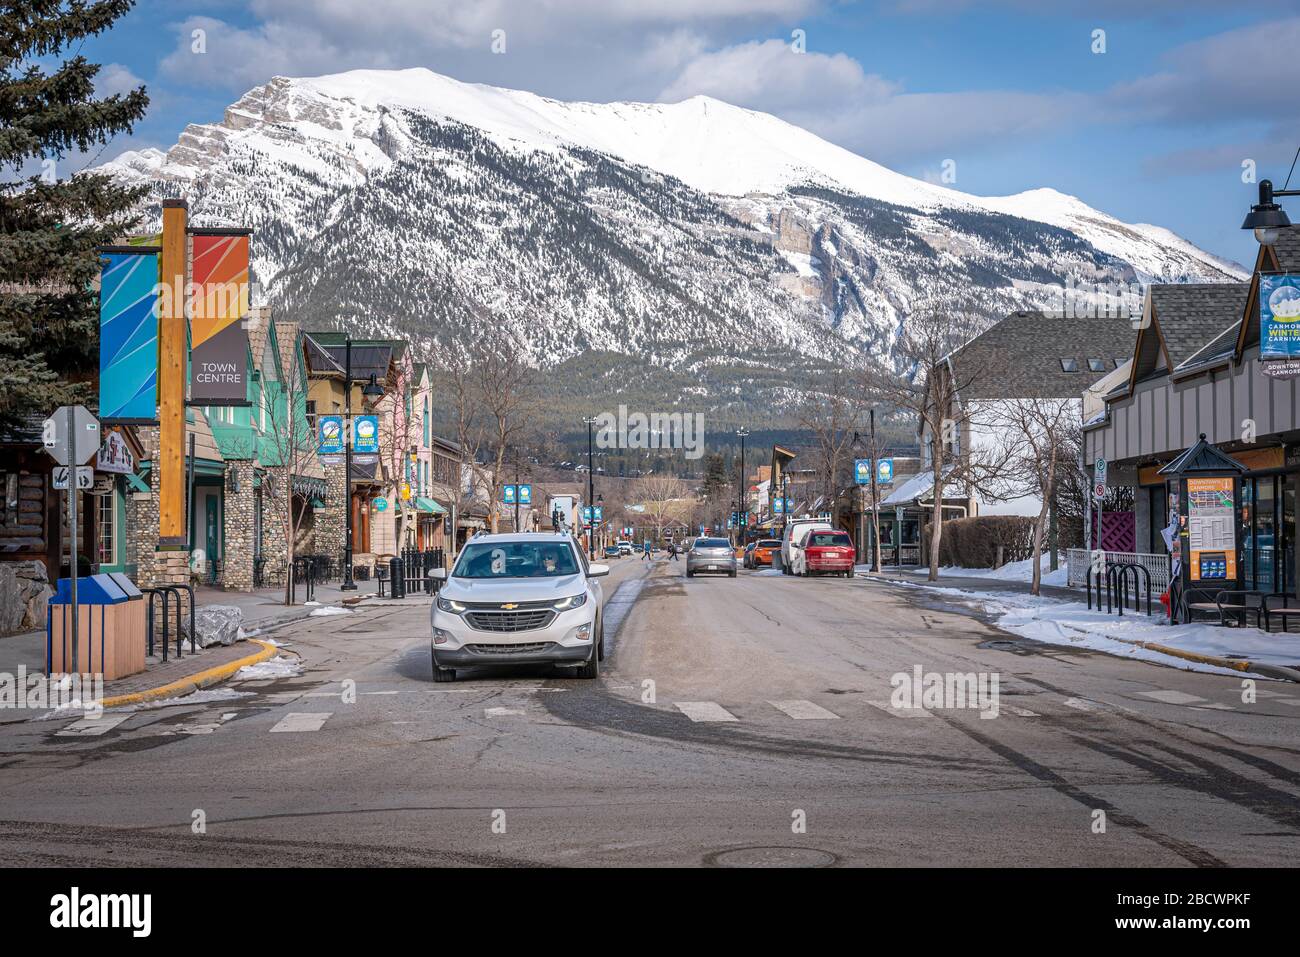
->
0, 583, 379, 723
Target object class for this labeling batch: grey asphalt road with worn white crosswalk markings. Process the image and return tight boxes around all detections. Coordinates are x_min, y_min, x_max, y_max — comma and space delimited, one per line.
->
0, 559, 1300, 866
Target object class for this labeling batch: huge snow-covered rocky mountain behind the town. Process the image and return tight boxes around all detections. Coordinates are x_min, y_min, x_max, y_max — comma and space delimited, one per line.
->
104, 69, 1244, 421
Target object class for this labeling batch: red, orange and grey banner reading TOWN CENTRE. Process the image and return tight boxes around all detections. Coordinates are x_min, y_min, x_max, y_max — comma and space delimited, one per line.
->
190, 230, 248, 406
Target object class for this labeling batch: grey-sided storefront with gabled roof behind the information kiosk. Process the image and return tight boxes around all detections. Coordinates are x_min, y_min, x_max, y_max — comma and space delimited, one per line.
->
1084, 229, 1300, 596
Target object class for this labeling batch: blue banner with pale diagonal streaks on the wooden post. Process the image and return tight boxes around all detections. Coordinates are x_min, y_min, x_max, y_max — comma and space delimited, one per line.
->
99, 247, 159, 423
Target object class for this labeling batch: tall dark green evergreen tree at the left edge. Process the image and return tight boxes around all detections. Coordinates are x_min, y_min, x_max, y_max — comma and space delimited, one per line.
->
0, 0, 148, 429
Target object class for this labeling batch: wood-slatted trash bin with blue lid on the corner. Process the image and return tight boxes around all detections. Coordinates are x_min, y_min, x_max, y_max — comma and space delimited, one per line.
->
46, 573, 147, 680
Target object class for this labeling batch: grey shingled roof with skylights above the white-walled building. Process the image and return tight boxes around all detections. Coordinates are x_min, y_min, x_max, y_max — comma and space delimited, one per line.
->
949, 312, 1138, 400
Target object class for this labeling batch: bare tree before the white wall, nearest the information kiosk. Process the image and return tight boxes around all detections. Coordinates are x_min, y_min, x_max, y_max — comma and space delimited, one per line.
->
991, 399, 1079, 594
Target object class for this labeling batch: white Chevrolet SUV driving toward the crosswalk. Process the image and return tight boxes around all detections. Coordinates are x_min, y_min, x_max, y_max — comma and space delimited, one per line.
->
432, 533, 610, 681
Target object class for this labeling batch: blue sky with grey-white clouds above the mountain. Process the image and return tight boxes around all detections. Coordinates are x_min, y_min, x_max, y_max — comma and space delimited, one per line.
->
85, 0, 1300, 264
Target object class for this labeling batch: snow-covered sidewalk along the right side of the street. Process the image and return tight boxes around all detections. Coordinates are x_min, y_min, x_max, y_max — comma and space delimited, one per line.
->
858, 567, 1300, 681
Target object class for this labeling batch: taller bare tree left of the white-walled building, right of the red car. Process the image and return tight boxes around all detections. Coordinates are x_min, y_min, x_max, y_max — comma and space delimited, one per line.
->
874, 311, 1009, 581
